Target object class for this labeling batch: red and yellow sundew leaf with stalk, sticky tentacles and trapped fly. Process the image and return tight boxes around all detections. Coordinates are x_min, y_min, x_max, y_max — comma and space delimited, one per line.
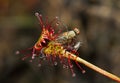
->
16, 13, 120, 82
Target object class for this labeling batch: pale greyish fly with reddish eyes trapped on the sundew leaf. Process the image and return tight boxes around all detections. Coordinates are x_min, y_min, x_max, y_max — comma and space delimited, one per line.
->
55, 28, 81, 51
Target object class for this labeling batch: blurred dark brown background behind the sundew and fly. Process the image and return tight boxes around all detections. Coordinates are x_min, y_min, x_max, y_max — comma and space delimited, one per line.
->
0, 0, 120, 83
